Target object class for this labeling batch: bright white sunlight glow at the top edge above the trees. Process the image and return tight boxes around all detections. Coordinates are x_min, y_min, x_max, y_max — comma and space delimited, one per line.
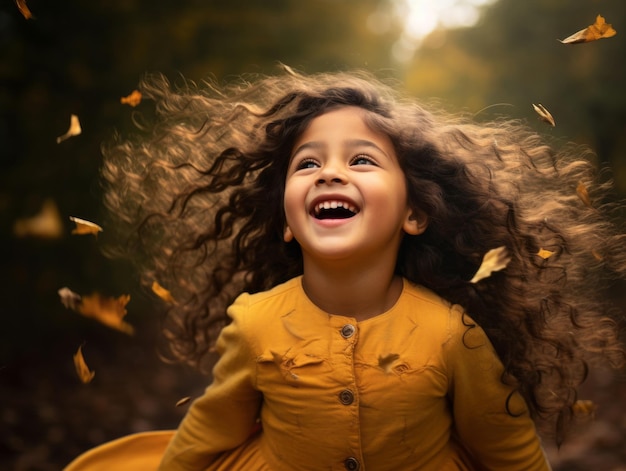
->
368, 0, 497, 62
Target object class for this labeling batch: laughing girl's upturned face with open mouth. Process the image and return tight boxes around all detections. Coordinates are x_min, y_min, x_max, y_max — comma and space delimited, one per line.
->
284, 106, 425, 266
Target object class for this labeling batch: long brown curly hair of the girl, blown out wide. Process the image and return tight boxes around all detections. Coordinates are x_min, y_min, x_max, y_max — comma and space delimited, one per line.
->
102, 69, 626, 441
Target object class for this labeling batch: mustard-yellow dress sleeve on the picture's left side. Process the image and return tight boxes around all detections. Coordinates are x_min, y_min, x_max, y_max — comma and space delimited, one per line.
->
159, 294, 261, 471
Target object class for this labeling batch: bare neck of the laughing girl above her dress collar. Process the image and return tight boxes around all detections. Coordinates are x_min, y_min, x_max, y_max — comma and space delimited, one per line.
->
302, 263, 403, 321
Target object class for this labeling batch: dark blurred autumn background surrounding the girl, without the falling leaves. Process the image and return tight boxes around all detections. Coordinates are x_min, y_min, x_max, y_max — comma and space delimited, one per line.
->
0, 0, 626, 471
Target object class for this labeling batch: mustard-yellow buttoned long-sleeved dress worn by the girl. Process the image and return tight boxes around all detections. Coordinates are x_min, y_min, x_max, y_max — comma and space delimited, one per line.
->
66, 277, 550, 471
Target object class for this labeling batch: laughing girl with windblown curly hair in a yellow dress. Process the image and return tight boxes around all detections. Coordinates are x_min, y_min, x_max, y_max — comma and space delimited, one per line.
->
67, 70, 626, 471
